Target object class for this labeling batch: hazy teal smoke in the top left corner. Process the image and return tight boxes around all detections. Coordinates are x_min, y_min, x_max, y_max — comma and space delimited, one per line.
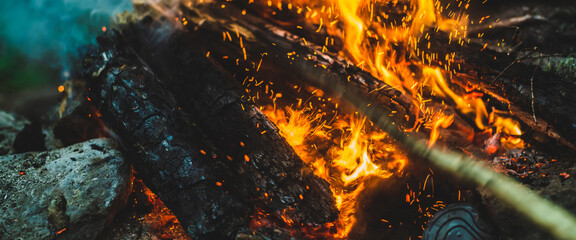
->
0, 0, 132, 78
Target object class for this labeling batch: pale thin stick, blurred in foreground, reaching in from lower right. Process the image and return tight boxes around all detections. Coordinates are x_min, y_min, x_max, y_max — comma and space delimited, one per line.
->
294, 58, 576, 239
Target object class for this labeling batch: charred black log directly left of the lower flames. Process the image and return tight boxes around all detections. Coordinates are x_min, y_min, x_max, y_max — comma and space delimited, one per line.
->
116, 24, 338, 225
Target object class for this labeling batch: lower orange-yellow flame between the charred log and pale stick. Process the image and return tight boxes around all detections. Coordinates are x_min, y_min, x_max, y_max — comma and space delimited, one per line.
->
263, 108, 406, 238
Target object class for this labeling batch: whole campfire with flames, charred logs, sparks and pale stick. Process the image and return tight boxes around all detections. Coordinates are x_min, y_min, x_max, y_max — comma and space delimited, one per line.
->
0, 0, 576, 239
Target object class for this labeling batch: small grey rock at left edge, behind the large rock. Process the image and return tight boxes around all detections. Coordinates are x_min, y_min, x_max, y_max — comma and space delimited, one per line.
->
0, 111, 30, 156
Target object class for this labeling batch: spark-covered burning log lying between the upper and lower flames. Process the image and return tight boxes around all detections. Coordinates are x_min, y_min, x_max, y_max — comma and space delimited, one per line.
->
143, 4, 417, 129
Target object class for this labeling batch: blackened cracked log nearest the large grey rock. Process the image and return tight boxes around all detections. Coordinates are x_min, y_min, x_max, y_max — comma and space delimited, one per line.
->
83, 31, 252, 239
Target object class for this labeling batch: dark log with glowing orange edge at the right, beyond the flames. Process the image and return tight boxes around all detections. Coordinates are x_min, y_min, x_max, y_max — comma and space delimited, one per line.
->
420, 33, 576, 149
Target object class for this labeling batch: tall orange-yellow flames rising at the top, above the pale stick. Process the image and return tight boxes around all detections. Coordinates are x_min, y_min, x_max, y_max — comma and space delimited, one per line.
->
332, 0, 522, 149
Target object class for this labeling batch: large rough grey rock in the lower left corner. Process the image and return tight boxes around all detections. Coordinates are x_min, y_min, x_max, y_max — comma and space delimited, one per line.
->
0, 139, 131, 239
